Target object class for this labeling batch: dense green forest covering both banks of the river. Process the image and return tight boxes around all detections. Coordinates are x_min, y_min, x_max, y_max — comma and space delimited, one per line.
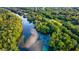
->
0, 7, 79, 51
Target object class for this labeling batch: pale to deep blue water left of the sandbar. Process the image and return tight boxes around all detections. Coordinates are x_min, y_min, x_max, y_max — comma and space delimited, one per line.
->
22, 17, 34, 39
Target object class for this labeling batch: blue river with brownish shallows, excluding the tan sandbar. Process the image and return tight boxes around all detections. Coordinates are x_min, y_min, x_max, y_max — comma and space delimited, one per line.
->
16, 14, 50, 51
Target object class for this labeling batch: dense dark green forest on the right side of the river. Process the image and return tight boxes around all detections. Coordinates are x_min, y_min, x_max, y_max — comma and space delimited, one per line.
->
0, 7, 79, 51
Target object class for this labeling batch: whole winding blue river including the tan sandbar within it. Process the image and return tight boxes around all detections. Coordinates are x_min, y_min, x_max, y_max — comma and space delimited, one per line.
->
19, 14, 50, 51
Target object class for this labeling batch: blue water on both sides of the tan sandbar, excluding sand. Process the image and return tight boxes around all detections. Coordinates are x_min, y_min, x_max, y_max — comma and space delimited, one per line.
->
18, 15, 50, 51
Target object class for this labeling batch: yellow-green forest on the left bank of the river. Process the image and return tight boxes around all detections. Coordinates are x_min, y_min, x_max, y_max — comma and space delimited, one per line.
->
0, 8, 22, 51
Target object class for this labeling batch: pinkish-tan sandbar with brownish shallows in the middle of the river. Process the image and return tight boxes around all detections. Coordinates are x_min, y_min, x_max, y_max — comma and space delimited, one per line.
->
5, 7, 41, 51
